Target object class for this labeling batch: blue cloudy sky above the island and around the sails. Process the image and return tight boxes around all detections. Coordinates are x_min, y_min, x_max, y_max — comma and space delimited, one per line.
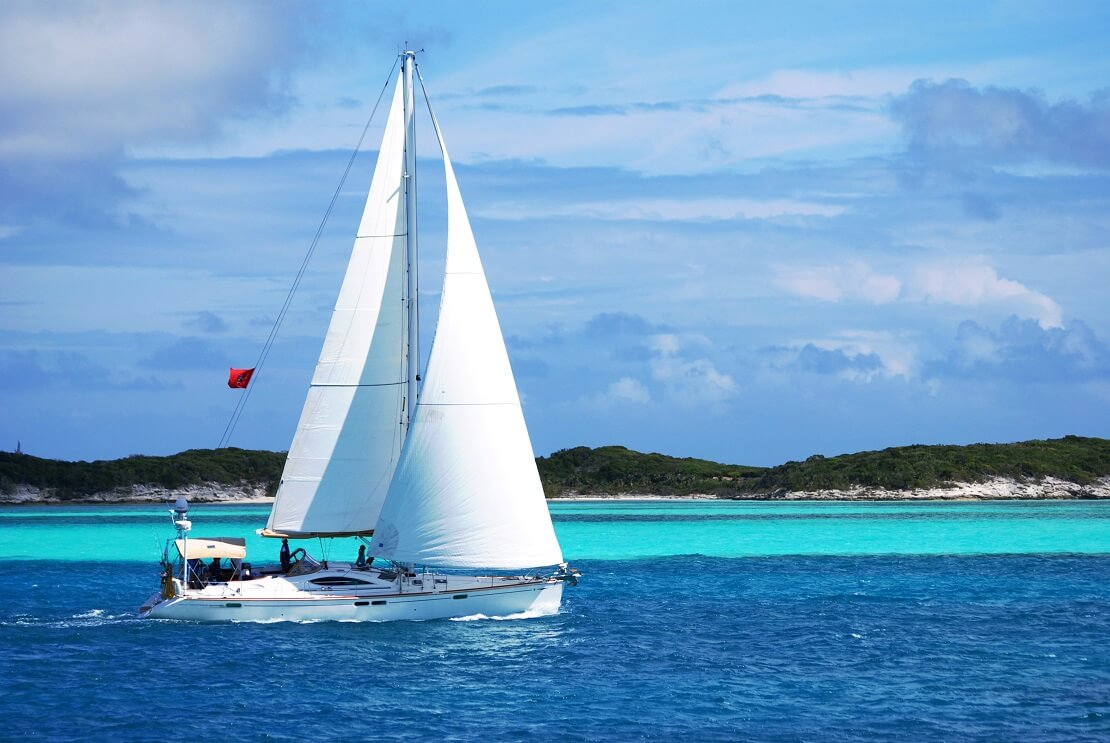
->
0, 0, 1110, 465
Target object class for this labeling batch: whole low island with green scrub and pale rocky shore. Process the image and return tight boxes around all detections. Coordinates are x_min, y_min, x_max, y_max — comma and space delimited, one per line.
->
0, 435, 1110, 504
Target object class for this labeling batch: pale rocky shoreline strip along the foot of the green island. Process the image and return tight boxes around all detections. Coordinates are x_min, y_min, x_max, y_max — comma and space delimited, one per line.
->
10, 478, 1110, 505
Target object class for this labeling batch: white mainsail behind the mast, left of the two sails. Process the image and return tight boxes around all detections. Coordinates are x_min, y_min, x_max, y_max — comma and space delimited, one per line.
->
266, 75, 406, 536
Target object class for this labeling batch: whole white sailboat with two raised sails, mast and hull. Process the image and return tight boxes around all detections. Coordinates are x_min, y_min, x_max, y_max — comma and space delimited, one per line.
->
140, 51, 578, 621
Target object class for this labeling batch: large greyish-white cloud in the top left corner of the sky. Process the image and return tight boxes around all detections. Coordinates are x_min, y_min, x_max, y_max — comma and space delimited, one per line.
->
0, 1, 295, 158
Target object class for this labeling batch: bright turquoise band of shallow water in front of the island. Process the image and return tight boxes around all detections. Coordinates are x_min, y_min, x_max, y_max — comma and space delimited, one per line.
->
0, 501, 1110, 561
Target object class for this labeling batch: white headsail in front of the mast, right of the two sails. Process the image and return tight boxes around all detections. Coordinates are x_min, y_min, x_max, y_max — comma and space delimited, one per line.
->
371, 111, 563, 568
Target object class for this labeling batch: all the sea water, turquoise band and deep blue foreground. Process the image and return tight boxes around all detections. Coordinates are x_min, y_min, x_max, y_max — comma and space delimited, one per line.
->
0, 501, 1110, 741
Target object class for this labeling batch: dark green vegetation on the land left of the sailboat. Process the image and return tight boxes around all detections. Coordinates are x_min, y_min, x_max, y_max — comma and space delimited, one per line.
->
0, 449, 285, 500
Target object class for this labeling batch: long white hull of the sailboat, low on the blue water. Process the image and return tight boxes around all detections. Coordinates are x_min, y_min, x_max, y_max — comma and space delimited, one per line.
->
140, 570, 563, 622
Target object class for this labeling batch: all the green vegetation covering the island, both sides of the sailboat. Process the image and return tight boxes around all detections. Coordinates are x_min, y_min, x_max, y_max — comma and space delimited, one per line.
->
0, 436, 1110, 500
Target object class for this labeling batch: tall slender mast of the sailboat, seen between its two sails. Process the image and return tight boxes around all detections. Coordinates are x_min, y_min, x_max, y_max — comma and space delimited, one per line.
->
401, 49, 420, 426
